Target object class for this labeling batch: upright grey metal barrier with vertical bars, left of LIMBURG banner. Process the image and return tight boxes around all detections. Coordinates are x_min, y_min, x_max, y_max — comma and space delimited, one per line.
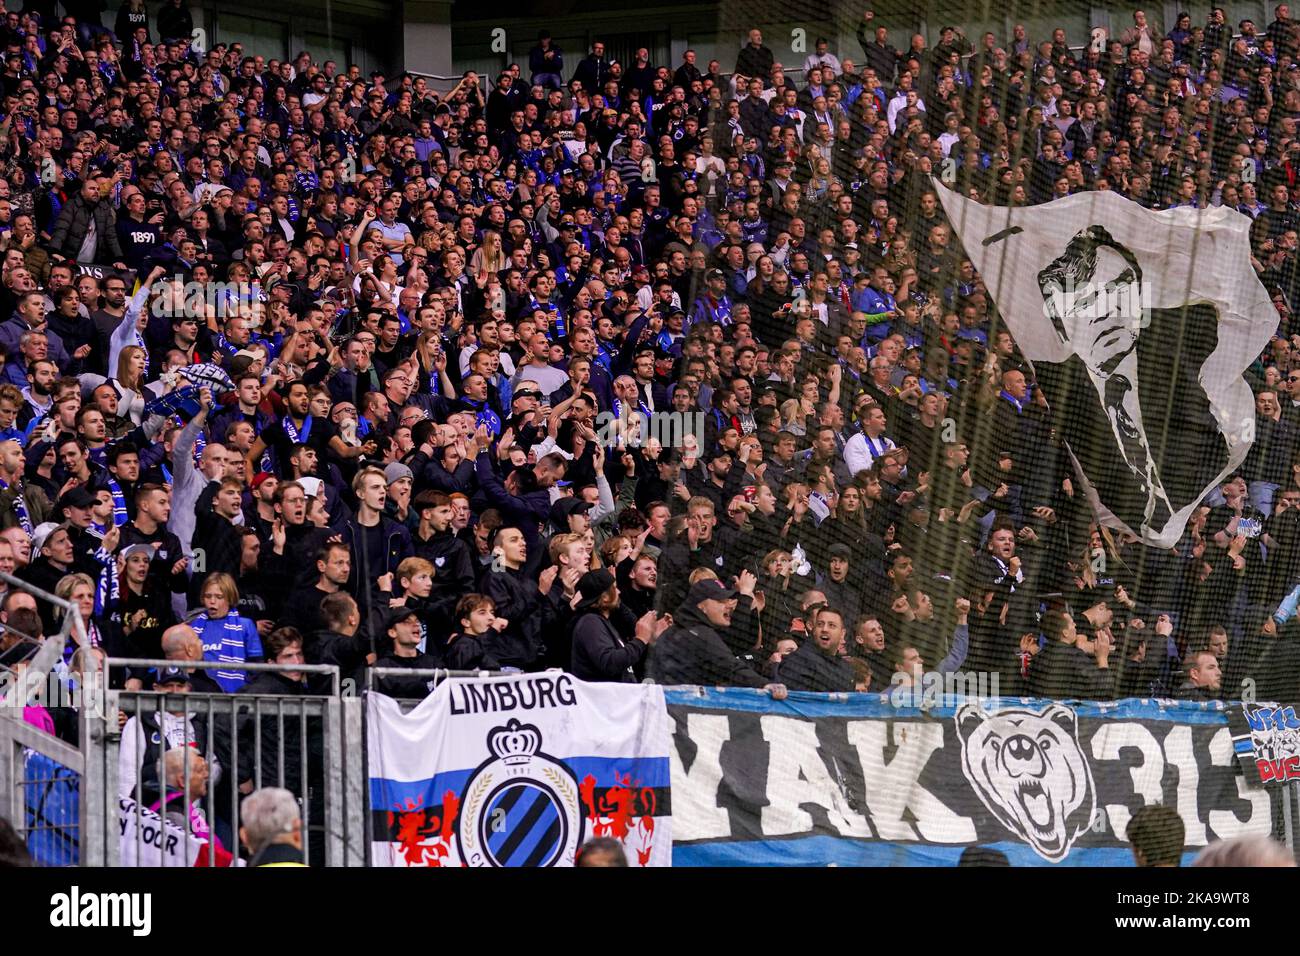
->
88, 658, 365, 866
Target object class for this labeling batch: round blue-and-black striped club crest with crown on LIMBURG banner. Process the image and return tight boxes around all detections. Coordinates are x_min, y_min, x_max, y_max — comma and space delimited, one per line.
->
456, 719, 585, 866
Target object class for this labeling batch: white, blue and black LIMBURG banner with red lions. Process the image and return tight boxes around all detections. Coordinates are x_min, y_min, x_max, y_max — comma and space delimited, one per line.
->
367, 671, 672, 866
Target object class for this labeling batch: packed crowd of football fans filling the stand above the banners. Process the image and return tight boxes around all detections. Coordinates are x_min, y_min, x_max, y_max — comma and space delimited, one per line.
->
0, 0, 1300, 786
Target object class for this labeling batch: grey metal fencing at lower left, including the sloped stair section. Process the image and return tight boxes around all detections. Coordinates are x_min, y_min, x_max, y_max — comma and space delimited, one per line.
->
0, 658, 365, 866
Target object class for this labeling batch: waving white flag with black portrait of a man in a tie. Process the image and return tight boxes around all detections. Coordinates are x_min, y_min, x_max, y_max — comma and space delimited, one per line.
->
936, 185, 1278, 548
